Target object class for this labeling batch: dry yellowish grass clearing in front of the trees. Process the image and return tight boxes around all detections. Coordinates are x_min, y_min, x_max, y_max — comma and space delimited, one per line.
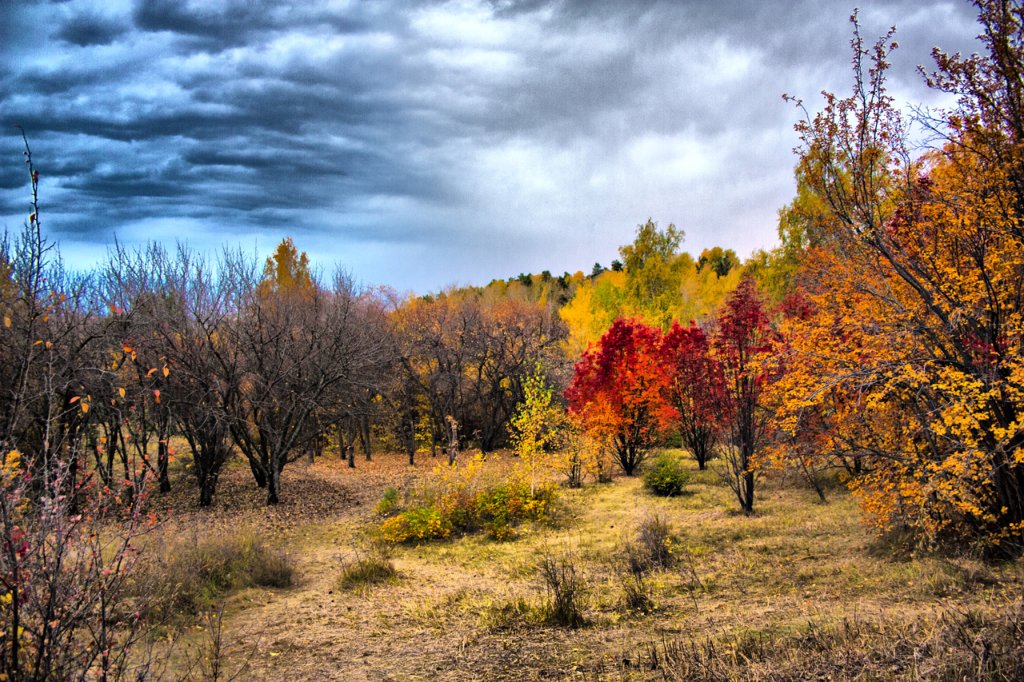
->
142, 454, 1024, 681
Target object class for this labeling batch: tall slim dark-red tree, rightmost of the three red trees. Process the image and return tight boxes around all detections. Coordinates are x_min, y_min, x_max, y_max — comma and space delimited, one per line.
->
712, 278, 776, 514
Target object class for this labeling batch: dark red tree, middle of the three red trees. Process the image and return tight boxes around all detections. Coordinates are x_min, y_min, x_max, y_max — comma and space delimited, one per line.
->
662, 323, 724, 470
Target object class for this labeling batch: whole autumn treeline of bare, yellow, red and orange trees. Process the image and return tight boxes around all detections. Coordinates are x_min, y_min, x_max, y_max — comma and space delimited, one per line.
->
0, 0, 1024, 677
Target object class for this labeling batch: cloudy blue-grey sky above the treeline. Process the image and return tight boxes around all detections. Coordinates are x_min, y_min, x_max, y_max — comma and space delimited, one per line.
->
0, 0, 980, 293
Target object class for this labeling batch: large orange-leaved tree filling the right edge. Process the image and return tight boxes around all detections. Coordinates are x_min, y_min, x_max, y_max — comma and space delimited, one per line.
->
778, 0, 1024, 550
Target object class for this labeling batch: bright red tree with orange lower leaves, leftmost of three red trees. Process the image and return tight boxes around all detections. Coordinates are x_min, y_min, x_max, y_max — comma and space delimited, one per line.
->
565, 319, 674, 476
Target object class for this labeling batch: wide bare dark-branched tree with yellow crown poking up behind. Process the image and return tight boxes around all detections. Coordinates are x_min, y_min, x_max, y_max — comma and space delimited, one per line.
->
232, 240, 389, 504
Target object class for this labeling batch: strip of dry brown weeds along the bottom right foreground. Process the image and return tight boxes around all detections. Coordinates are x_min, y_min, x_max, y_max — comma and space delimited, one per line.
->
591, 600, 1024, 682
